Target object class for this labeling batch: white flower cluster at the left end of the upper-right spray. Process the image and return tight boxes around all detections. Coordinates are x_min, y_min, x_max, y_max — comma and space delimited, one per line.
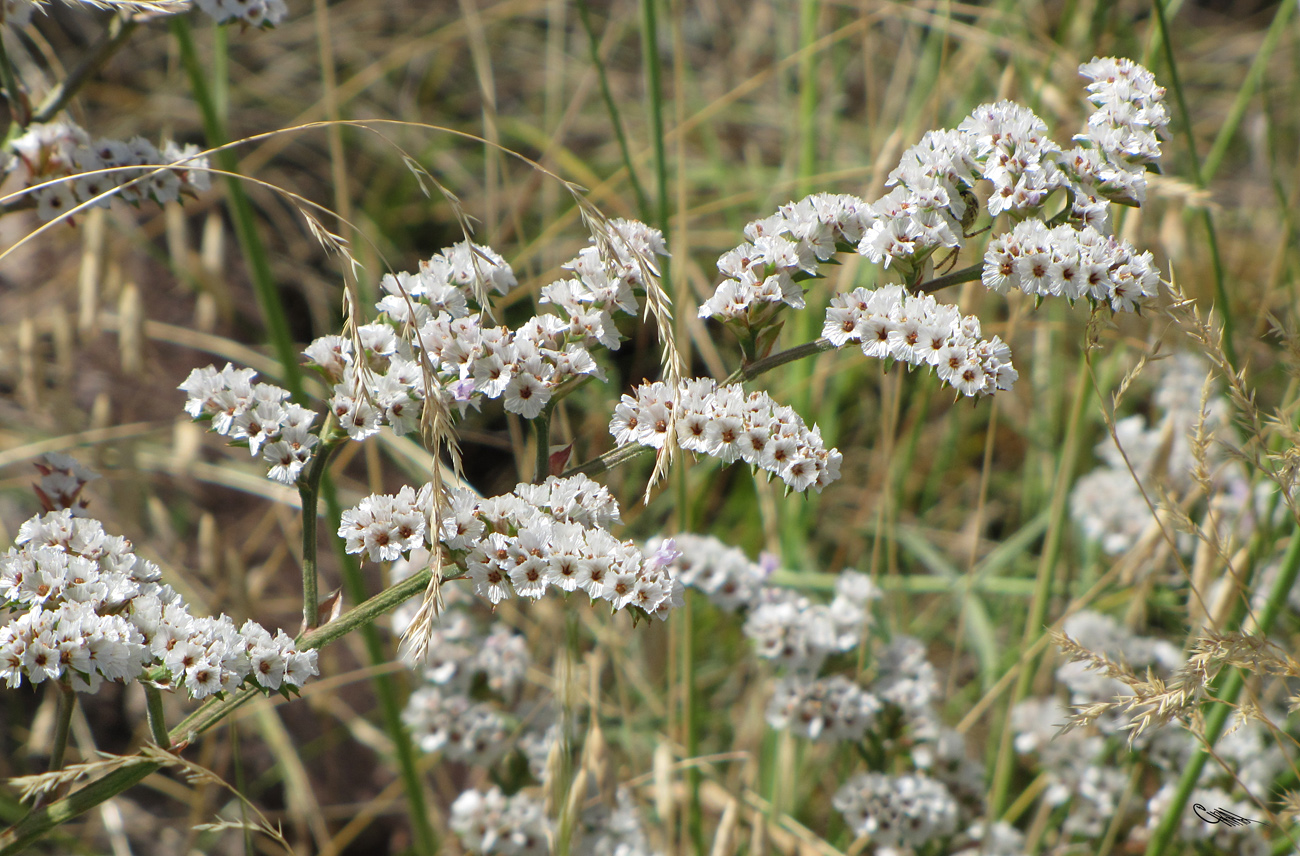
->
699, 194, 875, 324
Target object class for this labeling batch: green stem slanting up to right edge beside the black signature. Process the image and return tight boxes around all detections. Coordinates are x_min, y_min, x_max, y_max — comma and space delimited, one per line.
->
1147, 527, 1300, 856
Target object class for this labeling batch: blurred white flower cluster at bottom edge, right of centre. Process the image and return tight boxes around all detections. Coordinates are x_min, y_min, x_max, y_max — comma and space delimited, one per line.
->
831, 773, 958, 849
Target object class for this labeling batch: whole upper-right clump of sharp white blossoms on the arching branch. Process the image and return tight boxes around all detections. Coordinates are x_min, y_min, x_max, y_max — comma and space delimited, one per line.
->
699, 59, 1169, 395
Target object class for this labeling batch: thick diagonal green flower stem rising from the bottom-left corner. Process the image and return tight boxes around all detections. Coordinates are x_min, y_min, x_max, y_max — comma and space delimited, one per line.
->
0, 570, 459, 856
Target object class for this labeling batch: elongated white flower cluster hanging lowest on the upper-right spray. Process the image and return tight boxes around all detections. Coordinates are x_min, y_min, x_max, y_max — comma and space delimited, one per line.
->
822, 285, 1019, 395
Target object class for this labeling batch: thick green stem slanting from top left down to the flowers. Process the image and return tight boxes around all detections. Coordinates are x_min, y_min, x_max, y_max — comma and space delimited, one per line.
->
170, 16, 307, 403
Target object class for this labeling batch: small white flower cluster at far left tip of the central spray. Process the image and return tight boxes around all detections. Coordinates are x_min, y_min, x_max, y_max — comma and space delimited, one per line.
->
177, 363, 320, 484
